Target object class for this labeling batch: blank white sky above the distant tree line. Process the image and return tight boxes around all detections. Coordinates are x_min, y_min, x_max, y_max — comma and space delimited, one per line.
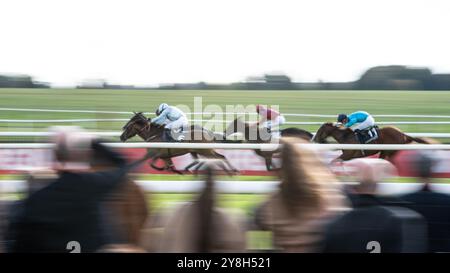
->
0, 0, 450, 86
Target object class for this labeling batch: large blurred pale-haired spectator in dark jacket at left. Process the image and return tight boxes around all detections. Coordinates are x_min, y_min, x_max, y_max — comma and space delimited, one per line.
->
8, 127, 147, 252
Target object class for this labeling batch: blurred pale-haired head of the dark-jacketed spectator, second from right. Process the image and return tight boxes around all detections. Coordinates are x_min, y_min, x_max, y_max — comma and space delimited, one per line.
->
351, 158, 396, 194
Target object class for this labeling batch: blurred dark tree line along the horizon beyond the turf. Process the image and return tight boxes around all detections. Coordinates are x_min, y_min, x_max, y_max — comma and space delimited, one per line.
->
0, 65, 450, 91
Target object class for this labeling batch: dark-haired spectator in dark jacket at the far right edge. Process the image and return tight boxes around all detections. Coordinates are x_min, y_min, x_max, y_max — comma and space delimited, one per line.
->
400, 152, 450, 252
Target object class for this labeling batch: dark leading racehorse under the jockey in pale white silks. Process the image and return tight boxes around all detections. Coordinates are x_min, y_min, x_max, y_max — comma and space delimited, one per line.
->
120, 112, 237, 174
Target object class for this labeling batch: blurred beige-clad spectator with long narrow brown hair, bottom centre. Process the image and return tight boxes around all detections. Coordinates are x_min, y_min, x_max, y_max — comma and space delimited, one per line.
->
161, 164, 246, 253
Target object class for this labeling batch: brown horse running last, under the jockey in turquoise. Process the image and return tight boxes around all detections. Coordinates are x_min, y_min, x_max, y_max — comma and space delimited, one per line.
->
312, 122, 429, 161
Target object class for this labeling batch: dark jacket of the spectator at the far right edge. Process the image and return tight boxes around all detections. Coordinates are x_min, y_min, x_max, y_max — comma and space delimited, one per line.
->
400, 186, 450, 252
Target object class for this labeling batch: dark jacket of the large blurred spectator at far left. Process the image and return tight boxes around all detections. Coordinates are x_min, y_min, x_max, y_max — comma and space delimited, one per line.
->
9, 143, 139, 252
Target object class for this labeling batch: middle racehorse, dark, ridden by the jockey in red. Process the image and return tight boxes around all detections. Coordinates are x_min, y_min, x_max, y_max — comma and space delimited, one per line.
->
224, 118, 313, 171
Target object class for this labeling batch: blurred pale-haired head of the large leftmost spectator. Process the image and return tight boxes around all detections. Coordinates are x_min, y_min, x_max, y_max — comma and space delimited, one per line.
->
50, 126, 94, 169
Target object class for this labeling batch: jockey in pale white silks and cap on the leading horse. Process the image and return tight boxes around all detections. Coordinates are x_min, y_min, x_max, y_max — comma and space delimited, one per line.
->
152, 103, 189, 141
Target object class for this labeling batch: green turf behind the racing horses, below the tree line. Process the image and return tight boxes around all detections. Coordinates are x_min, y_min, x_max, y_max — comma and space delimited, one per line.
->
0, 89, 450, 135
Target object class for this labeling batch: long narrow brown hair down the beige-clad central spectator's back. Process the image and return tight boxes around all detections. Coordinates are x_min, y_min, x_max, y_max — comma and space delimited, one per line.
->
194, 167, 215, 253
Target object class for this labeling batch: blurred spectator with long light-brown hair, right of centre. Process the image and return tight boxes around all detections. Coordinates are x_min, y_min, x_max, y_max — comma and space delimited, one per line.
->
256, 139, 348, 252
